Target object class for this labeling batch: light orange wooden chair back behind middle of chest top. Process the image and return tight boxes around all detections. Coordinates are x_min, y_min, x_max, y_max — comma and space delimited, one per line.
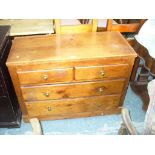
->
54, 19, 97, 34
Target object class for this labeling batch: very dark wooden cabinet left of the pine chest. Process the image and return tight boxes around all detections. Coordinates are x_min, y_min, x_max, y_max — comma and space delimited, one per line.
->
0, 26, 21, 127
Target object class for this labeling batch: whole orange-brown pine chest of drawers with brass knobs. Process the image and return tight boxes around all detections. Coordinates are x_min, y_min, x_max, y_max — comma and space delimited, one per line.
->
7, 32, 136, 121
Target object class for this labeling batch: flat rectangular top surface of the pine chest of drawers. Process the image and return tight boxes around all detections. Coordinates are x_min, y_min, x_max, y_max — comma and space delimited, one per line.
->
7, 32, 136, 64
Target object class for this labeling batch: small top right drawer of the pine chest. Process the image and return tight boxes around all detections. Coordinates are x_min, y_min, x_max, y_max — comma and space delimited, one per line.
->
75, 64, 129, 80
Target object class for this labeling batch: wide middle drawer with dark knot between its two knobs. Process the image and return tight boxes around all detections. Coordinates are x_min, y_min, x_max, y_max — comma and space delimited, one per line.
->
21, 79, 125, 101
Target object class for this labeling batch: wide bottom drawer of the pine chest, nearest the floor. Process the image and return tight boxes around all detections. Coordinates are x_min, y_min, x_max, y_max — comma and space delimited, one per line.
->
25, 95, 120, 117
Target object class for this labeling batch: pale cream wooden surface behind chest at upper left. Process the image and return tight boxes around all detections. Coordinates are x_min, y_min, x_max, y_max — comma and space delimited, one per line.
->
0, 19, 54, 37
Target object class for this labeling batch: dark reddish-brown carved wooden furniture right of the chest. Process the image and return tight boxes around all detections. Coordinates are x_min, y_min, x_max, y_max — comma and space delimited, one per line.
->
131, 41, 155, 110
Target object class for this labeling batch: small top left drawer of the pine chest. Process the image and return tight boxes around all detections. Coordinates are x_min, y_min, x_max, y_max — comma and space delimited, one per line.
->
17, 68, 73, 85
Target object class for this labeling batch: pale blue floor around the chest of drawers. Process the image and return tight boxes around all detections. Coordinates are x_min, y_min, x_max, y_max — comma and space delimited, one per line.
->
0, 83, 145, 135
